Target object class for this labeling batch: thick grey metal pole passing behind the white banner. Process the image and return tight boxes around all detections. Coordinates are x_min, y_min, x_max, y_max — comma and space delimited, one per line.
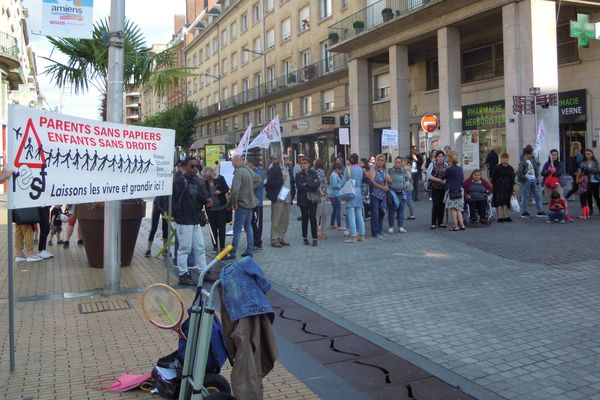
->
104, 0, 125, 295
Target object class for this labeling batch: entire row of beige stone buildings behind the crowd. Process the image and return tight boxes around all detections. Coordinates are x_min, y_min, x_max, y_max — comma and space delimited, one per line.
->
184, 0, 600, 169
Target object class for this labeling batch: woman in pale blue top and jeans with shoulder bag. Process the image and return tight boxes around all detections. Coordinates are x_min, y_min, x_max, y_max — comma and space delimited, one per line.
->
342, 153, 368, 243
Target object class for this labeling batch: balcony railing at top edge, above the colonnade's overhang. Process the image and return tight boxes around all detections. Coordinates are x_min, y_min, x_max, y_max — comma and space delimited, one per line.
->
328, 0, 443, 46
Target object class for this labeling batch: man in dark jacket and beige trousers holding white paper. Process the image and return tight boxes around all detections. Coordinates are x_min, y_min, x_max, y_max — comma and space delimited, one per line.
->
265, 154, 296, 247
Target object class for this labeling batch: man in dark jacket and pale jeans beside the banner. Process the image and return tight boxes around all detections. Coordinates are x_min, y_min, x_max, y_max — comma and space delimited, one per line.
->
173, 157, 212, 286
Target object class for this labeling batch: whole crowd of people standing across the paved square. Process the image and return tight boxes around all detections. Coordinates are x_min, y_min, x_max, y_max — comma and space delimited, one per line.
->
15, 142, 600, 285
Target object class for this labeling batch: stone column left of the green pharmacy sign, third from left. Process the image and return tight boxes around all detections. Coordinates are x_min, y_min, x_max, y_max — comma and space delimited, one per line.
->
437, 27, 462, 158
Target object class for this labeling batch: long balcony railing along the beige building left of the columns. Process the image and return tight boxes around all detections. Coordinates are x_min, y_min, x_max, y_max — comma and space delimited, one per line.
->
198, 54, 348, 118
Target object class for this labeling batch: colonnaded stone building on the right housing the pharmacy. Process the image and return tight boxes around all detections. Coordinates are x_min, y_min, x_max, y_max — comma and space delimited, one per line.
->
329, 0, 600, 169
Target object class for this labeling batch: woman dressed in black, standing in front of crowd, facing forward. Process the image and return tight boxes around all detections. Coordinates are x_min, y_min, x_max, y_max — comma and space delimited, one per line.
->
296, 157, 321, 246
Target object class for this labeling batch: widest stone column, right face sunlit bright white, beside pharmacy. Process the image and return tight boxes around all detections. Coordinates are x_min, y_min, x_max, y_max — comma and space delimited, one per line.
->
502, 0, 560, 165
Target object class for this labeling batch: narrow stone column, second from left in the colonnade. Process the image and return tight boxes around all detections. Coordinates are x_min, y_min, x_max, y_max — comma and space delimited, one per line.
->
389, 45, 410, 157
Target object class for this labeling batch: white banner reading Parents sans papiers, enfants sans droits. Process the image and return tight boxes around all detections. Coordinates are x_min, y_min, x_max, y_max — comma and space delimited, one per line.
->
7, 105, 175, 209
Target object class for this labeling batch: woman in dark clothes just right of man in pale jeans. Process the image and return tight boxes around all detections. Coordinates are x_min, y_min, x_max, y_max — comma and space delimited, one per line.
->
201, 167, 229, 254
